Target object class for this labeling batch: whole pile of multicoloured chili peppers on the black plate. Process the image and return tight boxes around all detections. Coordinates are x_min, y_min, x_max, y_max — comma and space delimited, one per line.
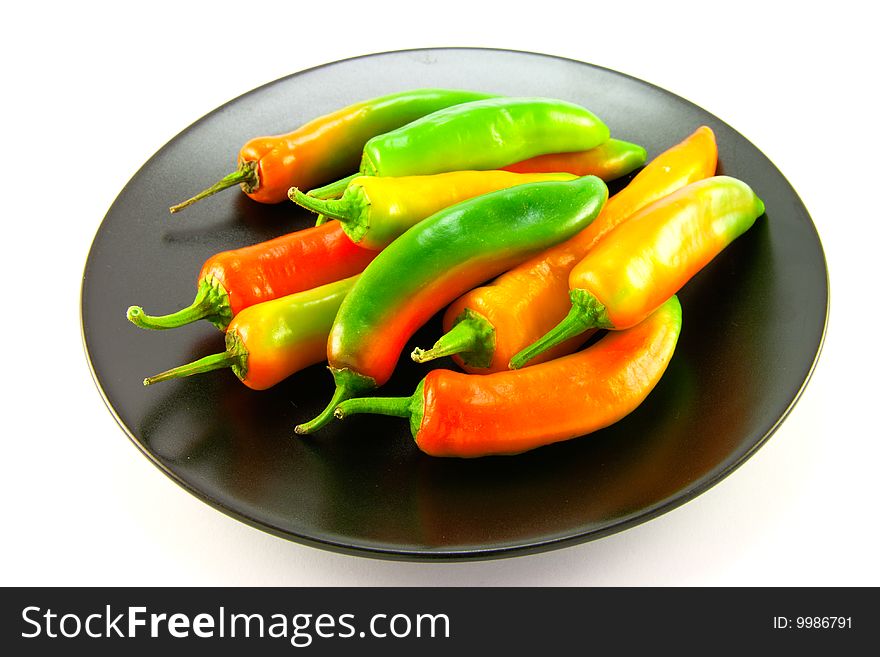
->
127, 89, 764, 457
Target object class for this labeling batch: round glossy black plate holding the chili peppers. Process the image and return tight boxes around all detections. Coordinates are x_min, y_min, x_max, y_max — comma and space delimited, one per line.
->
82, 49, 828, 559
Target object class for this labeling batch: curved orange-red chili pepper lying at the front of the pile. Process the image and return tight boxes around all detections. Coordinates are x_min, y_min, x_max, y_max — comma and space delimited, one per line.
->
335, 297, 681, 458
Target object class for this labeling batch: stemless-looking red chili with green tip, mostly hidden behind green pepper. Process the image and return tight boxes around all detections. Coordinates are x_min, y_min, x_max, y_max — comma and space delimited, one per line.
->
502, 139, 648, 182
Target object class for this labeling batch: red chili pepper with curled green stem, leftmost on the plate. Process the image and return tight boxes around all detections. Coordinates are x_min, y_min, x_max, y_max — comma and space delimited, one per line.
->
127, 221, 376, 330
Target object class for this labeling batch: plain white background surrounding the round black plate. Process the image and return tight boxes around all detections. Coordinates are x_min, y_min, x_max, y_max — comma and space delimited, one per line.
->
0, 0, 880, 586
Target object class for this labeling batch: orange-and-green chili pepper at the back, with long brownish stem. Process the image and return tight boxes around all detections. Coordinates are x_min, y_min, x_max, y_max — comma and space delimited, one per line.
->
171, 89, 492, 212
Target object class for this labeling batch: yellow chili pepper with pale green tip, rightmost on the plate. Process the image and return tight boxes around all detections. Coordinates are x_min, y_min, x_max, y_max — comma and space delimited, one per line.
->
510, 176, 764, 369
